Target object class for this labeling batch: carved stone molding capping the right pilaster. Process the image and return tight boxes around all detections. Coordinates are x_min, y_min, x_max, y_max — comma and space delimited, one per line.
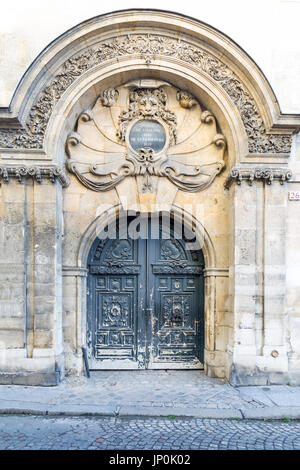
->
224, 167, 292, 189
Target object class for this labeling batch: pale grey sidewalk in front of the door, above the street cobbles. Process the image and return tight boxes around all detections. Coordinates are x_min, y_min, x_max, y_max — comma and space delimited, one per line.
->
0, 370, 300, 419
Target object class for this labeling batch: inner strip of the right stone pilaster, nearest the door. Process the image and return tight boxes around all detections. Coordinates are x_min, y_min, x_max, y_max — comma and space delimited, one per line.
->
228, 180, 257, 380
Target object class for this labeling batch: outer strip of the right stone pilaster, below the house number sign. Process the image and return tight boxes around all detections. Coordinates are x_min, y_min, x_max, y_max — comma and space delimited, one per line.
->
257, 184, 288, 383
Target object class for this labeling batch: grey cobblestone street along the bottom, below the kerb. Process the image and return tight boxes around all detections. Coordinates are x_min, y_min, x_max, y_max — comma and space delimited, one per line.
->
0, 415, 300, 450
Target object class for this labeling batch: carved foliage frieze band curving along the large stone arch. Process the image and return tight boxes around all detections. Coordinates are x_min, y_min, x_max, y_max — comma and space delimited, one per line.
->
0, 34, 292, 154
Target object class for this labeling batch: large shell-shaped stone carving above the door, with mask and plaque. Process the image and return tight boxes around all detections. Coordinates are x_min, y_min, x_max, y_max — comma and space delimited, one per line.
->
66, 84, 226, 193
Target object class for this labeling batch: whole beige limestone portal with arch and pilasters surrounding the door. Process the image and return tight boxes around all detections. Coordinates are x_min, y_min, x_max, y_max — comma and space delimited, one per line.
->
0, 11, 300, 385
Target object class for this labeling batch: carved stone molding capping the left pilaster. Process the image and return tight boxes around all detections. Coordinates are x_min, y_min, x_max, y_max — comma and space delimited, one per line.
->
0, 165, 69, 188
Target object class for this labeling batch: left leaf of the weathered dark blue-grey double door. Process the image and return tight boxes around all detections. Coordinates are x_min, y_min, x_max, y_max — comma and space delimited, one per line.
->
87, 239, 145, 369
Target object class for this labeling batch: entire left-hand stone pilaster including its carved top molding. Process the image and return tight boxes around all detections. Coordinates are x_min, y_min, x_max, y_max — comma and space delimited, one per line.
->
0, 166, 64, 385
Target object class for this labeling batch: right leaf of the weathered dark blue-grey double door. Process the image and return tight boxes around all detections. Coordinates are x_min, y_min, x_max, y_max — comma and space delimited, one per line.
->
148, 239, 203, 369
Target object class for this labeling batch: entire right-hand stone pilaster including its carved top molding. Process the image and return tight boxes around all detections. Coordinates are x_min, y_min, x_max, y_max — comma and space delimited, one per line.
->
226, 168, 291, 385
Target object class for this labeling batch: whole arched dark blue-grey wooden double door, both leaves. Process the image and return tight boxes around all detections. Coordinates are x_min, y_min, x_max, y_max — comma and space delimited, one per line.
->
87, 216, 204, 370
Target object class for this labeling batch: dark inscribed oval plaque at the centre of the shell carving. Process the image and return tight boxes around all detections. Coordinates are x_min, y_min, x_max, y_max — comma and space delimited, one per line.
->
129, 120, 166, 153
